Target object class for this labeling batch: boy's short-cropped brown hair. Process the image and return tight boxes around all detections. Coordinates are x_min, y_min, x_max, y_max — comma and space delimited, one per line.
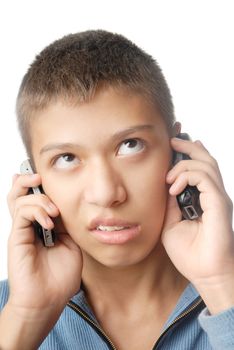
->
16, 30, 175, 154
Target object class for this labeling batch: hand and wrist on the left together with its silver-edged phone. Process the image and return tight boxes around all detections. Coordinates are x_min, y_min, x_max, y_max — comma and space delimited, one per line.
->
0, 161, 83, 349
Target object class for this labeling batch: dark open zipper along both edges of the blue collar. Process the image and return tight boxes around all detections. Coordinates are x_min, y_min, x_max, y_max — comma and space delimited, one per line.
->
67, 298, 203, 350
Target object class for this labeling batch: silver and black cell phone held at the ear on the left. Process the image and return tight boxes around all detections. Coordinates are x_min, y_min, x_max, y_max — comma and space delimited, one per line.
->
20, 159, 55, 247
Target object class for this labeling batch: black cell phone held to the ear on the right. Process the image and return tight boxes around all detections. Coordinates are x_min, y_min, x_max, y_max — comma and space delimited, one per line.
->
173, 133, 203, 220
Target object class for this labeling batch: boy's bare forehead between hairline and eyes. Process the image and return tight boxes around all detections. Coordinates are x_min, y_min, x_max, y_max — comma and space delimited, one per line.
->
30, 88, 168, 152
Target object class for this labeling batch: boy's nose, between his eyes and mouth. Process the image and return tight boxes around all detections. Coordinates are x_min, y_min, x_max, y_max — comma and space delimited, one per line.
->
84, 161, 127, 208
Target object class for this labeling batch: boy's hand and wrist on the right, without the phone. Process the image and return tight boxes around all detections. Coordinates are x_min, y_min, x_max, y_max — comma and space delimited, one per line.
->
162, 138, 234, 313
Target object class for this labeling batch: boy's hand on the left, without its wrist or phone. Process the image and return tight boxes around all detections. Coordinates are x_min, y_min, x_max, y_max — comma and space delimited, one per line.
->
2, 174, 82, 344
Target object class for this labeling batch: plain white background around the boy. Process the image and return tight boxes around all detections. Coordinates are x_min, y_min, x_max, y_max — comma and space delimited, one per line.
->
0, 0, 234, 279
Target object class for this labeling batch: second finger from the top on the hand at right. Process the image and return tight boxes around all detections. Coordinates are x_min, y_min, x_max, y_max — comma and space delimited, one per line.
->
167, 160, 224, 189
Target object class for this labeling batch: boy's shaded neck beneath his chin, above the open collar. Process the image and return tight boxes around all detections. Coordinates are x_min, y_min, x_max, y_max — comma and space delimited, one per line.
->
82, 244, 188, 309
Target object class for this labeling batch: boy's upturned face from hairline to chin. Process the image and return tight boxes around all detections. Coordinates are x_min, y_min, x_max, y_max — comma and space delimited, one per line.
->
31, 88, 171, 267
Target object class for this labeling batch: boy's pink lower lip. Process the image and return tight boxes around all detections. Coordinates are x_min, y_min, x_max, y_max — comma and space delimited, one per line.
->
90, 225, 140, 244
